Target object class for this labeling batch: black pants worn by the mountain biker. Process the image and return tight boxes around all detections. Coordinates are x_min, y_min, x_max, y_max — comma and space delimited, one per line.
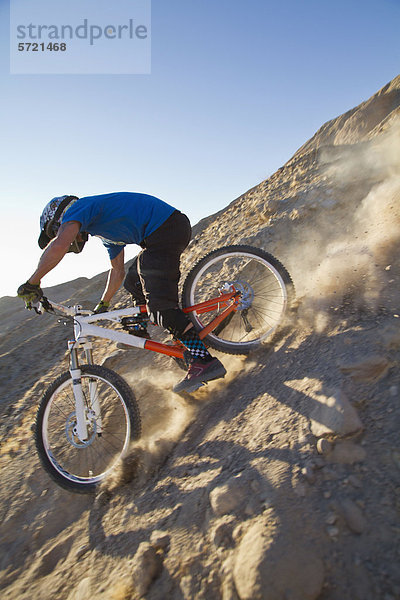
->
124, 210, 192, 313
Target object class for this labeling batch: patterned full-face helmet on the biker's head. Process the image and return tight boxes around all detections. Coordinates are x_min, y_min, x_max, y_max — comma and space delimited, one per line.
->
38, 196, 88, 254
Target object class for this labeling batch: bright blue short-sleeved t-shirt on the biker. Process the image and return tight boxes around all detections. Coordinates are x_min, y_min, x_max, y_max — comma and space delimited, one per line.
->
61, 192, 175, 259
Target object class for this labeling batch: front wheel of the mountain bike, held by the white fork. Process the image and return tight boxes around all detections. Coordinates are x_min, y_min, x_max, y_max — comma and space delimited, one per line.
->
35, 365, 141, 493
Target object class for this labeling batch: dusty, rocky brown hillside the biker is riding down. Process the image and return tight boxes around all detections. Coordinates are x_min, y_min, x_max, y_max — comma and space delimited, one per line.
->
0, 77, 400, 600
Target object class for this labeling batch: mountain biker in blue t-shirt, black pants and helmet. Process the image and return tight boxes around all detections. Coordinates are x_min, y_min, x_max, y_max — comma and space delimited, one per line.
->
17, 192, 226, 392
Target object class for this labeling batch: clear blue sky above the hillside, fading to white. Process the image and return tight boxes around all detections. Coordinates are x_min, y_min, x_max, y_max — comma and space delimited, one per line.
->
0, 0, 400, 296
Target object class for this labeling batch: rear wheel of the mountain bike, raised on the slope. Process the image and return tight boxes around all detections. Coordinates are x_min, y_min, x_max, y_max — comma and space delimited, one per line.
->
182, 246, 294, 354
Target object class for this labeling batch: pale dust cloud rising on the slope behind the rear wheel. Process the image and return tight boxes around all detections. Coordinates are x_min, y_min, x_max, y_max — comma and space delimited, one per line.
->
290, 118, 400, 329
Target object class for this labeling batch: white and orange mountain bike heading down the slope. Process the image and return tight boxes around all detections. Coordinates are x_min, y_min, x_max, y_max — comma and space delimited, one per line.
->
30, 246, 294, 492
